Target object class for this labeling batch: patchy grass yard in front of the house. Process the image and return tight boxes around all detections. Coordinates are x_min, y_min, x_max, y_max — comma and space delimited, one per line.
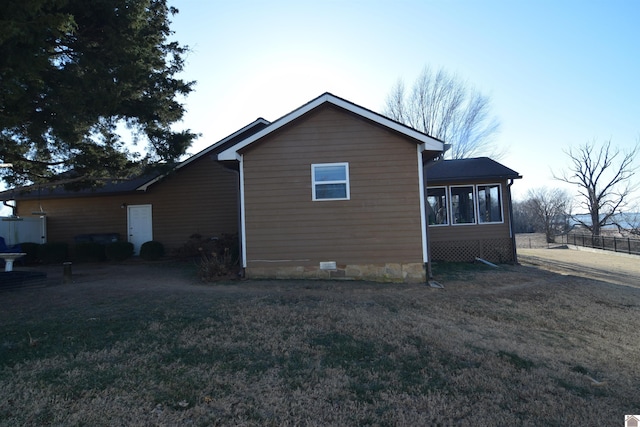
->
0, 265, 640, 426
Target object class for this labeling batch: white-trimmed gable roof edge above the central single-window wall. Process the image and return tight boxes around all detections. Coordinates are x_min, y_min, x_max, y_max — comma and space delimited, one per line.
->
218, 92, 445, 160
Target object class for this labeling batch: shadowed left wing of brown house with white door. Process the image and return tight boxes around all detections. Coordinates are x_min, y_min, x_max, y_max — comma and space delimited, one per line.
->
0, 119, 269, 253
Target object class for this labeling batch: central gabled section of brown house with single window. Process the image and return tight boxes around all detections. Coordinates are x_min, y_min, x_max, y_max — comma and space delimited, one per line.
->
218, 93, 444, 281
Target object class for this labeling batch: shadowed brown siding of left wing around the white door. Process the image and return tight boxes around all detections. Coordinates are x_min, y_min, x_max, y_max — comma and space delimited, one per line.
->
18, 156, 238, 250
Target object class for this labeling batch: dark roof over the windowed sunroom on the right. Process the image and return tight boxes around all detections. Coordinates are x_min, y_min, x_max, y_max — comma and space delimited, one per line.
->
425, 157, 522, 184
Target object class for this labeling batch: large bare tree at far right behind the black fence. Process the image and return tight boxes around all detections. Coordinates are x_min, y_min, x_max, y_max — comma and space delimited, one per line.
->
553, 140, 640, 236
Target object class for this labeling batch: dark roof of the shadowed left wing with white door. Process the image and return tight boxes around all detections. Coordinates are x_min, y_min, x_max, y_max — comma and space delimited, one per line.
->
0, 118, 270, 200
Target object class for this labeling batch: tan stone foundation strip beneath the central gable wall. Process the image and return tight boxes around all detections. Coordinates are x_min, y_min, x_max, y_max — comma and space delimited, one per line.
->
245, 263, 427, 283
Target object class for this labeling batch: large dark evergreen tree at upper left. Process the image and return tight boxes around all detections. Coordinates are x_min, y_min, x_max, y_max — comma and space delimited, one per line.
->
0, 0, 195, 185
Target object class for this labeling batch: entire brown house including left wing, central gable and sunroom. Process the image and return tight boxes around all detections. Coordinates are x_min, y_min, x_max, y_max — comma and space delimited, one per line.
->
0, 93, 520, 282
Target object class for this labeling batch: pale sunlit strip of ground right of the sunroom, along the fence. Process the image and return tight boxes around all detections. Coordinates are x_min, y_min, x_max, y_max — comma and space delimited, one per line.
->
518, 246, 640, 287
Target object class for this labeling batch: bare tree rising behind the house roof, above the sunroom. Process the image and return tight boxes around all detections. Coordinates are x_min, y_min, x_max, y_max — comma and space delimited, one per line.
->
383, 67, 504, 159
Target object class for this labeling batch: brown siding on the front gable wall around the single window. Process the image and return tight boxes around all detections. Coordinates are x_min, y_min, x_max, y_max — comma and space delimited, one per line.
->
244, 107, 422, 265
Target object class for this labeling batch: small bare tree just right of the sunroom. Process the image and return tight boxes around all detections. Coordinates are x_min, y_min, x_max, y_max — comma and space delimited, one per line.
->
525, 187, 572, 243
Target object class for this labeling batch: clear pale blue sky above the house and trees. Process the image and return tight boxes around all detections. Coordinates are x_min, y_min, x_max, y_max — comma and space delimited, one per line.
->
169, 0, 640, 203
